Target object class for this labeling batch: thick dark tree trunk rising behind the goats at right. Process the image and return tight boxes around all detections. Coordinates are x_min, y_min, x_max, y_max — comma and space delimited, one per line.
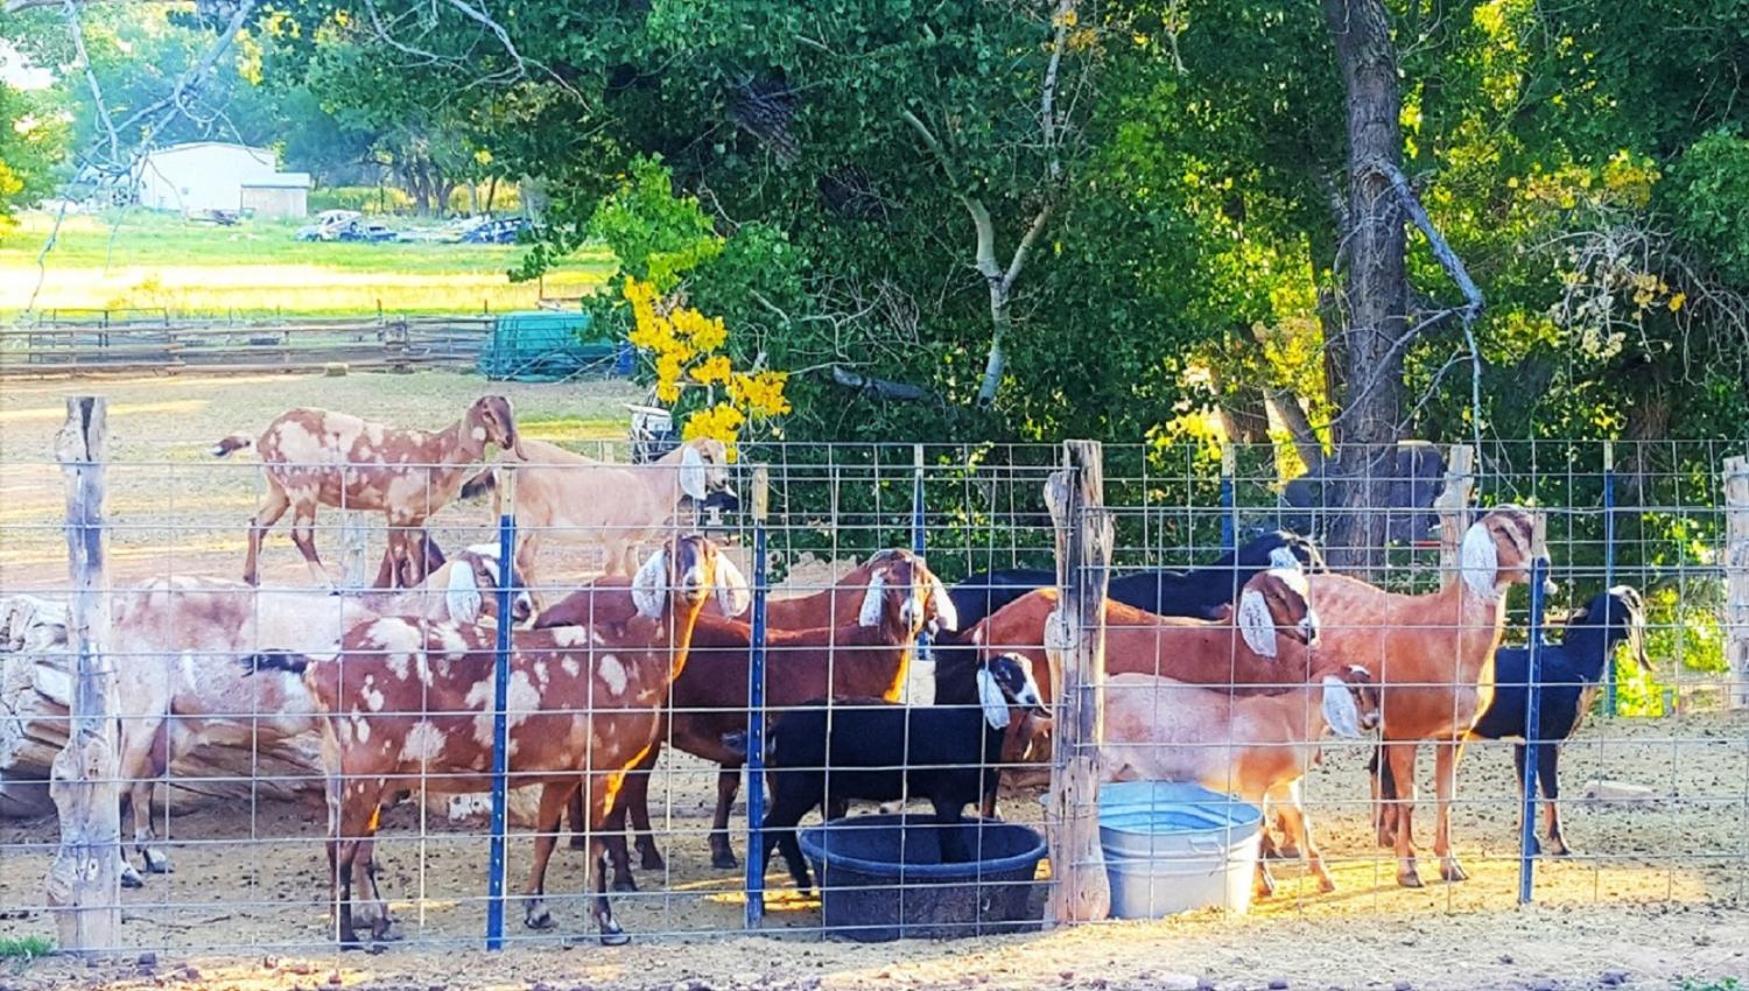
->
1324, 0, 1410, 572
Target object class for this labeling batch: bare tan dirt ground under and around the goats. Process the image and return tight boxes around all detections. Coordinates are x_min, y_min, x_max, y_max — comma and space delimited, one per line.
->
0, 372, 1749, 991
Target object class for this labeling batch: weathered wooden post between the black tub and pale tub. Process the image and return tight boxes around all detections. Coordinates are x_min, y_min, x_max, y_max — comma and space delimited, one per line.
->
1044, 440, 1112, 925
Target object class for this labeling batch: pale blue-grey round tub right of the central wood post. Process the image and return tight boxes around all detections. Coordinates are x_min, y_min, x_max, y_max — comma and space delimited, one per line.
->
1098, 781, 1263, 919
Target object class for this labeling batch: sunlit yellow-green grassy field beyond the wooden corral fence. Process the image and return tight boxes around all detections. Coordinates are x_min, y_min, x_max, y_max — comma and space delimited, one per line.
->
0, 210, 614, 318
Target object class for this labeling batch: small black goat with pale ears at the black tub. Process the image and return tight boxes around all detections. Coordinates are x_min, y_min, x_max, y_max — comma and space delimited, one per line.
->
755, 654, 1046, 891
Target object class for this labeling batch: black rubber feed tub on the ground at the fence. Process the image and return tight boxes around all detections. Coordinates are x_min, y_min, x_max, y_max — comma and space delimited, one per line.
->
799, 814, 1044, 942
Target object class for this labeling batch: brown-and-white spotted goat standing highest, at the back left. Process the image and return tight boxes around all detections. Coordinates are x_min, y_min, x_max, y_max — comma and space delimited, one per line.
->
213, 395, 523, 587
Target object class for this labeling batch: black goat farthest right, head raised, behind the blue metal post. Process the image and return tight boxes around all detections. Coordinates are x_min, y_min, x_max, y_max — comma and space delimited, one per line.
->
1373, 586, 1651, 856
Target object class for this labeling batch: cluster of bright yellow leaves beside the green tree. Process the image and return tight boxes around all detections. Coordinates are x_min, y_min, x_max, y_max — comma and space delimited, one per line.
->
621, 274, 791, 460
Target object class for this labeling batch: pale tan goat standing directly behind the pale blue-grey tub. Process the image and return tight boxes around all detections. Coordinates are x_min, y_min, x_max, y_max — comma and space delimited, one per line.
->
1102, 668, 1378, 897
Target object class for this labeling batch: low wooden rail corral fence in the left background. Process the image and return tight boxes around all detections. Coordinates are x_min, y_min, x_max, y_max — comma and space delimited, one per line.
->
0, 311, 495, 378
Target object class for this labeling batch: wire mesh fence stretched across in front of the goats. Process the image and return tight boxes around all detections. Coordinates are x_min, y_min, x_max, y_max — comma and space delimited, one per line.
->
0, 428, 1749, 951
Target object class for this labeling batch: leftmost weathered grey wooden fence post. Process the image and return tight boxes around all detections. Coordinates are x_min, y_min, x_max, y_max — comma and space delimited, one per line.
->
44, 395, 121, 954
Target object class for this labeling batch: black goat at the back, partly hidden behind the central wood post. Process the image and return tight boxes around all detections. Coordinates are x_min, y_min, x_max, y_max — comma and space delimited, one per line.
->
951, 530, 1322, 629
